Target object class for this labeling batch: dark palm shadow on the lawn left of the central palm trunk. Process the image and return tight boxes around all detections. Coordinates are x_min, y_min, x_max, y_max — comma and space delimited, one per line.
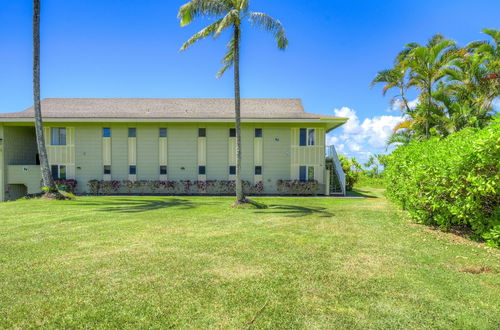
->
77, 198, 199, 213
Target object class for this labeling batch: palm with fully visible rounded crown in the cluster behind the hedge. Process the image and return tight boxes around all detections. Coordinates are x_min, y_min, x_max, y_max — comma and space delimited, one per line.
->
398, 34, 458, 138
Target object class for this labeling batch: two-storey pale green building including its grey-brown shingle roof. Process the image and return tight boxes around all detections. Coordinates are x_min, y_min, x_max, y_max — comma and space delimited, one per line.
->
0, 98, 346, 201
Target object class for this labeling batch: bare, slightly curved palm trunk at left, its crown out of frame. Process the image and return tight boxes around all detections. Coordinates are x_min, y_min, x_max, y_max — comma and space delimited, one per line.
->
33, 0, 56, 191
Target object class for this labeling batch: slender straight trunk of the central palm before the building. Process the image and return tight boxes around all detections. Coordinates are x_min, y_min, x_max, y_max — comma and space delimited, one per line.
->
234, 25, 245, 203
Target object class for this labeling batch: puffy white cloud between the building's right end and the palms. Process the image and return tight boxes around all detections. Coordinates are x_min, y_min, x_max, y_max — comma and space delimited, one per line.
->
327, 107, 404, 162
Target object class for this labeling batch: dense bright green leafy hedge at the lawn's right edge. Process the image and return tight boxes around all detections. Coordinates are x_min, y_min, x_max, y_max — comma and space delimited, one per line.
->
384, 119, 500, 245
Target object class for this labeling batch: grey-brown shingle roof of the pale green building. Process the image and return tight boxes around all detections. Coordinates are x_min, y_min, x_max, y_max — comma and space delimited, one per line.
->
0, 98, 341, 119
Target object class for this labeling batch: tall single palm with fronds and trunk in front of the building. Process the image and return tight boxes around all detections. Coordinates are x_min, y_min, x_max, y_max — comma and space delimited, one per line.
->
178, 0, 288, 203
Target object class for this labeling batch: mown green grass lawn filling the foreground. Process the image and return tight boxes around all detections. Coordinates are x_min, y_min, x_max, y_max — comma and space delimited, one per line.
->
0, 189, 500, 329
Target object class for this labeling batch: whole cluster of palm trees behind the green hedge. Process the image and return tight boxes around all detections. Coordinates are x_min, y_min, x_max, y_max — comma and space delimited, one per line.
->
372, 29, 500, 145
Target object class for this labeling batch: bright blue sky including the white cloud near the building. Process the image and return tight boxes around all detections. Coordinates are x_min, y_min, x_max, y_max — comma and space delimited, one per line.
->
0, 0, 500, 157
